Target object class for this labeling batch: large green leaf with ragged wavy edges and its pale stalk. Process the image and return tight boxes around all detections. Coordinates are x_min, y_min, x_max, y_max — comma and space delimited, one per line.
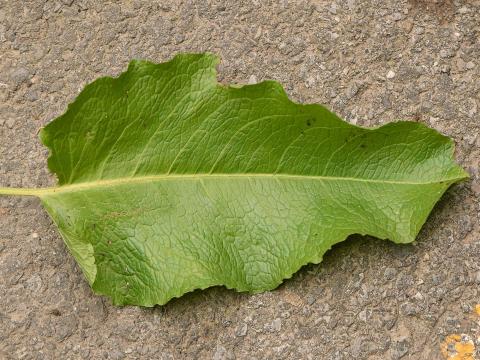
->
0, 54, 467, 306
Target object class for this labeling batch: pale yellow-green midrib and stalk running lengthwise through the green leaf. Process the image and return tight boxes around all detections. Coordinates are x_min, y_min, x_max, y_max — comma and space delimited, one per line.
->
0, 174, 463, 197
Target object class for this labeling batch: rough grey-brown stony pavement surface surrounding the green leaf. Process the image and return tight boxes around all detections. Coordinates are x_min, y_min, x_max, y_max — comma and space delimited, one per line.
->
0, 0, 480, 359
